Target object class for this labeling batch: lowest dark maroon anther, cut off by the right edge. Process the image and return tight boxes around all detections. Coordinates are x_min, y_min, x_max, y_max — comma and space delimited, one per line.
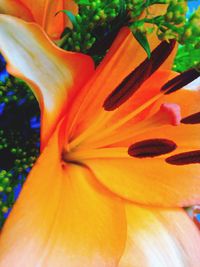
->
165, 150, 200, 165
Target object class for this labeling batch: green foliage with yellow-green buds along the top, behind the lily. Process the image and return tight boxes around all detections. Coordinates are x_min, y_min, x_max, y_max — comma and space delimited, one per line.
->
58, 0, 200, 60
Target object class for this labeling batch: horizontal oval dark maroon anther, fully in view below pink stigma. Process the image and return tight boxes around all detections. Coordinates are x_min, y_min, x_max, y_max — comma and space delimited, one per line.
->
128, 139, 177, 158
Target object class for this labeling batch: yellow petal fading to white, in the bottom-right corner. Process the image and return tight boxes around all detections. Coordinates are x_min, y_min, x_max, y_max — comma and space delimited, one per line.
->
119, 205, 200, 267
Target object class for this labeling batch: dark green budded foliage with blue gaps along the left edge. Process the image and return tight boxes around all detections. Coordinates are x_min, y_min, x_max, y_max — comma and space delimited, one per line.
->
0, 77, 39, 227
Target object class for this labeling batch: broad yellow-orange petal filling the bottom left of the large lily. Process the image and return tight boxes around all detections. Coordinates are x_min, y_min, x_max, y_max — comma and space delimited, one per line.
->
0, 121, 126, 267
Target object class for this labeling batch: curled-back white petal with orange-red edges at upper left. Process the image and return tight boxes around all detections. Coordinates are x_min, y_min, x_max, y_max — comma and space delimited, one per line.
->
0, 15, 94, 147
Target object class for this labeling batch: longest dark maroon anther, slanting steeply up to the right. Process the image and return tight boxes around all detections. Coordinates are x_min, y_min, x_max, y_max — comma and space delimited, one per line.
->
103, 40, 175, 111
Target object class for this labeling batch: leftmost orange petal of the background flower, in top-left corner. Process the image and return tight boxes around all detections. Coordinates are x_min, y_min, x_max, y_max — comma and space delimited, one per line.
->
0, 0, 33, 21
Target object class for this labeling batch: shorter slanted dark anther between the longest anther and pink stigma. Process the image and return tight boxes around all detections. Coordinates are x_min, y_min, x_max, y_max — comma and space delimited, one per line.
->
161, 68, 200, 95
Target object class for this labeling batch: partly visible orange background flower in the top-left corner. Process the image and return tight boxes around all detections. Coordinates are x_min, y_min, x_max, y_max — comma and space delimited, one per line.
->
0, 0, 78, 39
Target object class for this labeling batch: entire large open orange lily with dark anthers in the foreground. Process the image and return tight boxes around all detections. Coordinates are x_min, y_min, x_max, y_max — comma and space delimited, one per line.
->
0, 15, 200, 267
